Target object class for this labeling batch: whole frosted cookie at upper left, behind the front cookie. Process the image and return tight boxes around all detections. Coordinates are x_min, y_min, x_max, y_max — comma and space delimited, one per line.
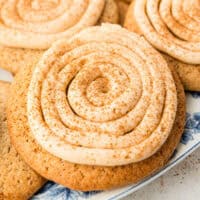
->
0, 0, 119, 74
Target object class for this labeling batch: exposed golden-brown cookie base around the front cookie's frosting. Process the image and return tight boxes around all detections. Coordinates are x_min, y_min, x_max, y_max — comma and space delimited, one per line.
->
8, 25, 185, 191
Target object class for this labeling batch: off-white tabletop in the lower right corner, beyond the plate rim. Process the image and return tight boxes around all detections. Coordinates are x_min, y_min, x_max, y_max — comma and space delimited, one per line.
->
123, 148, 200, 200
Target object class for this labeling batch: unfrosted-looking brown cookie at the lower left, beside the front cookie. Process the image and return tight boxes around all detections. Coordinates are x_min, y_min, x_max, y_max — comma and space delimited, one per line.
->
0, 81, 45, 200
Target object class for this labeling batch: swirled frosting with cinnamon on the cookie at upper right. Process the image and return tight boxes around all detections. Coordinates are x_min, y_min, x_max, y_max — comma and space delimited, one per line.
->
127, 0, 200, 64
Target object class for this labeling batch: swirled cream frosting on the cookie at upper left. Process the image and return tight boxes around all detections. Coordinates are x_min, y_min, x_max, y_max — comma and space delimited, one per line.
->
0, 0, 105, 49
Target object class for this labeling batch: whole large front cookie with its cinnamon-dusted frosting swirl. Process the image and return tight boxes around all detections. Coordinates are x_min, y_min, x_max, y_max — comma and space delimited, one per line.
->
8, 24, 185, 191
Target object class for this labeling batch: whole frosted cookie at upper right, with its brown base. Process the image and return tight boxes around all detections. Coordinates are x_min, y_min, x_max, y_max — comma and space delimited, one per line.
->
125, 0, 200, 91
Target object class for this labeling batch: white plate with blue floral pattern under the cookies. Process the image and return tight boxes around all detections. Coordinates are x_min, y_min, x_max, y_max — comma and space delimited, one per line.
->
0, 69, 200, 200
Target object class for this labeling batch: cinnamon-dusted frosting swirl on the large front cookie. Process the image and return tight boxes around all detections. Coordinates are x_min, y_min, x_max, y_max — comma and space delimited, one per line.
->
27, 24, 177, 166
